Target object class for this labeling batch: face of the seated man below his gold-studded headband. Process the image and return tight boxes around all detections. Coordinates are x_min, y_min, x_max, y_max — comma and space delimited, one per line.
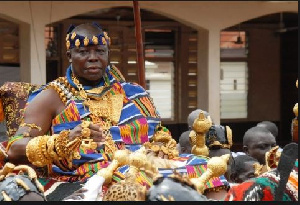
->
68, 45, 108, 81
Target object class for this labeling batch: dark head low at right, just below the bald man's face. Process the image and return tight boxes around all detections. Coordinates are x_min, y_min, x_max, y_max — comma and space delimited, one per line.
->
229, 155, 258, 183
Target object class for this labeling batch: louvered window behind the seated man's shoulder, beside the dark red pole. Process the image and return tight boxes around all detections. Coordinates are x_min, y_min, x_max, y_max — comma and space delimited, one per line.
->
145, 29, 175, 120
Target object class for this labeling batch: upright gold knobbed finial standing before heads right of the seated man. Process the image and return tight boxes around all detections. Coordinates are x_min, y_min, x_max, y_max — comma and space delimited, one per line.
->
189, 111, 212, 156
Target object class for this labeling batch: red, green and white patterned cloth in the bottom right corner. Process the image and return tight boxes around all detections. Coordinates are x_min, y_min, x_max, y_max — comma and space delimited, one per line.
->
225, 159, 298, 201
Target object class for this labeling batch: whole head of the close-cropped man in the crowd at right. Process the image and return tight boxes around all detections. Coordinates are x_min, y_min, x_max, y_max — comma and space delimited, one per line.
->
243, 127, 276, 165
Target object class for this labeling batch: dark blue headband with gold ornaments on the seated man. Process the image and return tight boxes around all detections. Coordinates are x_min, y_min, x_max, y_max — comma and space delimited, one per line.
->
66, 23, 111, 50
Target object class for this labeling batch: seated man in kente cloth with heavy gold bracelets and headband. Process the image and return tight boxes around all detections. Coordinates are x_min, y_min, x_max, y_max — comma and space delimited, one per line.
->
7, 23, 160, 182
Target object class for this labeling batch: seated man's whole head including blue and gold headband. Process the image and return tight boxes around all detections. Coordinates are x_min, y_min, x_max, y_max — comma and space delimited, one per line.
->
66, 23, 110, 85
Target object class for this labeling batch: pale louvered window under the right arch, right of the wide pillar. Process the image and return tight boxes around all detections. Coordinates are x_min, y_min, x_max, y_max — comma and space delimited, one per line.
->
220, 31, 248, 119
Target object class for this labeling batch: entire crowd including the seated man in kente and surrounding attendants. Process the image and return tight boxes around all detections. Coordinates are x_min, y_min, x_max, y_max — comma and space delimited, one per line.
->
0, 23, 298, 201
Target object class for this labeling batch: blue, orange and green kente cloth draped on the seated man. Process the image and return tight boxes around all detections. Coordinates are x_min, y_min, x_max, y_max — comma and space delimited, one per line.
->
28, 65, 160, 182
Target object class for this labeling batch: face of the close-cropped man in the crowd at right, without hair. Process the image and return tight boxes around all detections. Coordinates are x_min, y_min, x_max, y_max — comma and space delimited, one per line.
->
245, 133, 276, 164
